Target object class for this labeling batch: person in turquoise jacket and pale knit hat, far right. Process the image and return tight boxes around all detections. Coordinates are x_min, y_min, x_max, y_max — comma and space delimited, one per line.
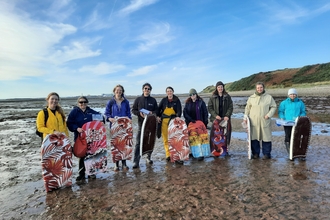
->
278, 88, 306, 153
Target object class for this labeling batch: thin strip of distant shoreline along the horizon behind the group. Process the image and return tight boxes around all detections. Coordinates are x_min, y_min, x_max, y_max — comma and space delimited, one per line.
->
0, 85, 330, 102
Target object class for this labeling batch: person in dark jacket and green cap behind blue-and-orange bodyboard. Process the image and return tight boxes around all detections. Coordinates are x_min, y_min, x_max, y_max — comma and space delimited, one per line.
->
183, 89, 209, 127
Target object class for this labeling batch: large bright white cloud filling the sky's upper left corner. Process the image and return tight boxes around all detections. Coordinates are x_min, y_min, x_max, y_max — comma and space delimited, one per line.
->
0, 3, 76, 80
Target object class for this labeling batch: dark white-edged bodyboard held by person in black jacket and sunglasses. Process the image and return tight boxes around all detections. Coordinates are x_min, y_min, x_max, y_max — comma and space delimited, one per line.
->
140, 114, 157, 156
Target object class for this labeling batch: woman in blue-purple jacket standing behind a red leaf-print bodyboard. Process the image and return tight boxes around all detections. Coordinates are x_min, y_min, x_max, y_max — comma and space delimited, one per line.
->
104, 85, 132, 171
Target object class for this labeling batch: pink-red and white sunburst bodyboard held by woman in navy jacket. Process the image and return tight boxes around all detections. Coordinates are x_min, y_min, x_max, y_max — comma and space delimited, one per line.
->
82, 121, 107, 175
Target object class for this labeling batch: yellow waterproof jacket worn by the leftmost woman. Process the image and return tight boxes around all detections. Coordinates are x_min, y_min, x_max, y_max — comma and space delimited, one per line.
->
36, 108, 69, 138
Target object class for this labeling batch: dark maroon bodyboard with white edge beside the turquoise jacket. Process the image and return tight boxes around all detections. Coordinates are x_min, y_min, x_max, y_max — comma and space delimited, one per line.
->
289, 116, 312, 160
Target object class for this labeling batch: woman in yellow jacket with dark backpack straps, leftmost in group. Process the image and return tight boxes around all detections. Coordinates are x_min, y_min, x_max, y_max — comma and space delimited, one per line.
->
36, 92, 69, 139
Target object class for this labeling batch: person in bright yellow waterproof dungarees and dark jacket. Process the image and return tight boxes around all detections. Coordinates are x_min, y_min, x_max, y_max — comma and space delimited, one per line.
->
158, 86, 182, 161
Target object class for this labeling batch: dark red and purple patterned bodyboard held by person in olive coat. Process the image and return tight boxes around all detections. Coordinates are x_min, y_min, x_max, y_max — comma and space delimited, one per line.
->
210, 119, 231, 157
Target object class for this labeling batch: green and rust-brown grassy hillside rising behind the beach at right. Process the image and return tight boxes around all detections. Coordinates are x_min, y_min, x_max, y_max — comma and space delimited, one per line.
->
202, 63, 330, 93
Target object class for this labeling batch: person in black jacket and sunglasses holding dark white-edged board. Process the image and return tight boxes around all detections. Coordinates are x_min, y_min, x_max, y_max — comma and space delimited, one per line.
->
132, 83, 158, 169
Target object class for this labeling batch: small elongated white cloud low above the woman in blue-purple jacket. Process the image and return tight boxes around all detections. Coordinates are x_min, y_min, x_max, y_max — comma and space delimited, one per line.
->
79, 62, 125, 75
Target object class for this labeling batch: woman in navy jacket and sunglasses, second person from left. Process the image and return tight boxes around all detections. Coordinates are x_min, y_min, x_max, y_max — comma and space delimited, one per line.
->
66, 96, 100, 181
